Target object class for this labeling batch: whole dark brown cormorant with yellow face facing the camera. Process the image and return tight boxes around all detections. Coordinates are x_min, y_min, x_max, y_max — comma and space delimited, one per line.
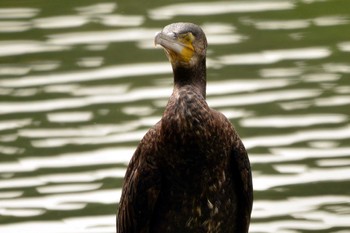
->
116, 22, 253, 233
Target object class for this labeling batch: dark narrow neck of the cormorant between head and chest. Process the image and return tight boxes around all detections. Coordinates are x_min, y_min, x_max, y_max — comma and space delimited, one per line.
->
173, 58, 207, 99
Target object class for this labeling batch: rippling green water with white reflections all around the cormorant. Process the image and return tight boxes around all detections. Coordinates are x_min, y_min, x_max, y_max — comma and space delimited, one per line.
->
0, 0, 350, 233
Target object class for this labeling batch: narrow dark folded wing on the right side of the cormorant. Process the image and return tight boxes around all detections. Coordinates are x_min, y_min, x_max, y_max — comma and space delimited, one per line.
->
231, 142, 253, 233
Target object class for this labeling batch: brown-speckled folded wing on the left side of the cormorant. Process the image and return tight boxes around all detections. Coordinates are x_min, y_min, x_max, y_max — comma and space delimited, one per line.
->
117, 125, 161, 233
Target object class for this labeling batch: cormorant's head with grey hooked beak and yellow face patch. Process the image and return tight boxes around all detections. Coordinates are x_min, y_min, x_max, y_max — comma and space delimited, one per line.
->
154, 23, 207, 67
